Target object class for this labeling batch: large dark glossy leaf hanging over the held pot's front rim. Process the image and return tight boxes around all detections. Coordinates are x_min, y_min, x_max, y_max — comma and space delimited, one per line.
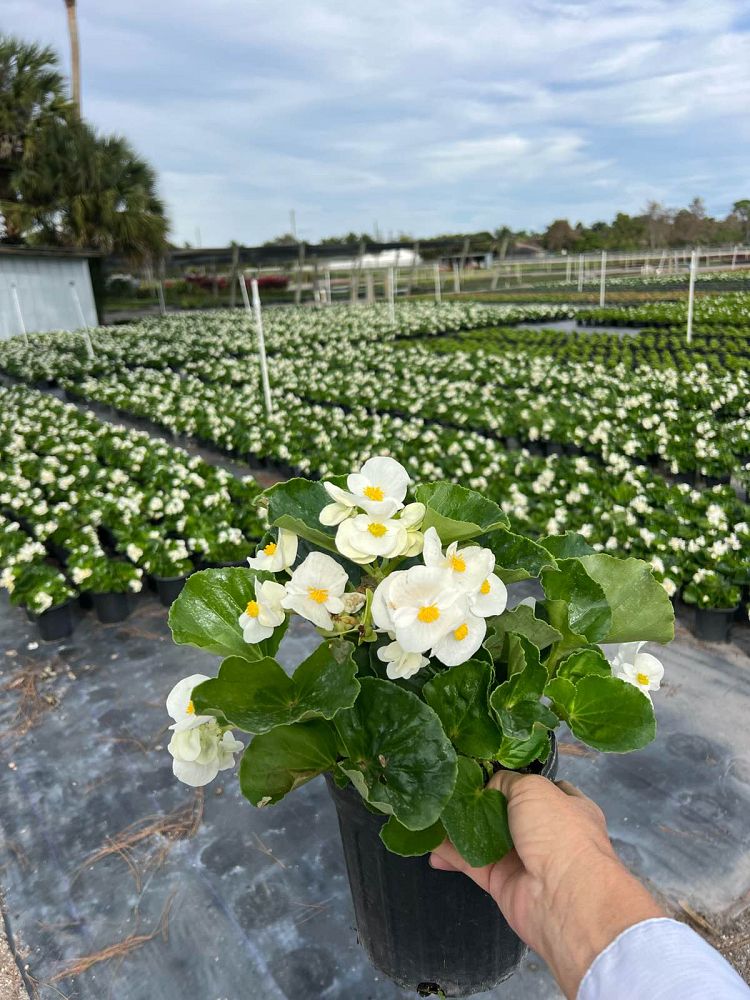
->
334, 677, 456, 830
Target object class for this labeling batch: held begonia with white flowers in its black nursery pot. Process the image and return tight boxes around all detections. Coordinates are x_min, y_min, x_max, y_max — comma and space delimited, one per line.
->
167, 457, 674, 996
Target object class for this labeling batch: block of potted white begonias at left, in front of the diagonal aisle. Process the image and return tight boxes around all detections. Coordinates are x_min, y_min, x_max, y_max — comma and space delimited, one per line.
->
0, 387, 264, 638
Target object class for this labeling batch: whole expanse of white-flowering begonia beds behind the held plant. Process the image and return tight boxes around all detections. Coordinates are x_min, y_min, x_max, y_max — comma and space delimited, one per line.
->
0, 293, 750, 640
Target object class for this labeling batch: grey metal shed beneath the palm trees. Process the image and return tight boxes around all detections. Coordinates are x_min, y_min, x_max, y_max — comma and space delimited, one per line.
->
0, 244, 97, 340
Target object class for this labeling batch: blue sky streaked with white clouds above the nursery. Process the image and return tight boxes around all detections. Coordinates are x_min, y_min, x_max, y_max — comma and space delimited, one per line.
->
5, 0, 750, 246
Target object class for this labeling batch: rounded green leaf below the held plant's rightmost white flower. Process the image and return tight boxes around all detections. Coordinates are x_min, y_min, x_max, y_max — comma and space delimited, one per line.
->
546, 675, 656, 753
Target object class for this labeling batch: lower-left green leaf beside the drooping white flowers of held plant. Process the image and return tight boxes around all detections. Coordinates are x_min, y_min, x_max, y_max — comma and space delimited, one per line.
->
240, 719, 337, 806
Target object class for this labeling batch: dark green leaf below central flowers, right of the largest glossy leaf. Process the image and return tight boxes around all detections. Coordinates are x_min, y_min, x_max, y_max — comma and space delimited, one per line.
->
422, 660, 503, 759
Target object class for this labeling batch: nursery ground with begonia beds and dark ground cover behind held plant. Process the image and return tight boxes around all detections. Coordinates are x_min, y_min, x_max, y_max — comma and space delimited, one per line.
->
0, 292, 750, 1000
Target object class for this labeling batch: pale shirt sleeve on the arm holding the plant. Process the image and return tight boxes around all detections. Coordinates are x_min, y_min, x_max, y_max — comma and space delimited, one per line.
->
577, 917, 750, 1000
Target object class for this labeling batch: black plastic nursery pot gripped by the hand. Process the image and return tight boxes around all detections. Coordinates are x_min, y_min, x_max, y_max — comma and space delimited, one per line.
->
326, 736, 557, 997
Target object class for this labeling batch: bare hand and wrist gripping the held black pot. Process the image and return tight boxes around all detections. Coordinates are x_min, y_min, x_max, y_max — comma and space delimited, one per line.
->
430, 771, 665, 1000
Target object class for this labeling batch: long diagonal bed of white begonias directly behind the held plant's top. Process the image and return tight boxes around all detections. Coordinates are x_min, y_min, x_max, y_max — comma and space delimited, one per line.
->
42, 360, 750, 640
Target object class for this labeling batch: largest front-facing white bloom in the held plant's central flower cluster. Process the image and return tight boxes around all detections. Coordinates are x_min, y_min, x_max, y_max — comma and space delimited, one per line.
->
388, 566, 466, 653
